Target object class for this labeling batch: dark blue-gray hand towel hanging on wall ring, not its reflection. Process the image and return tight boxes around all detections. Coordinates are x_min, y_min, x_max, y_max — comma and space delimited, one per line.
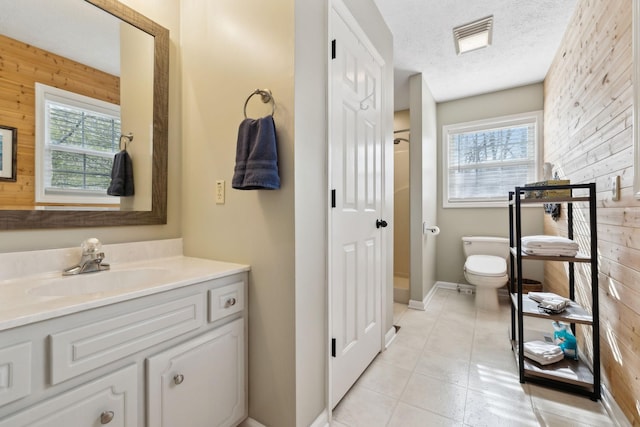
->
231, 116, 280, 190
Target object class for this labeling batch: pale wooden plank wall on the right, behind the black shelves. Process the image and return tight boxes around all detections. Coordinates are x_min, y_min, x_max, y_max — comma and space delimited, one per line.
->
544, 0, 640, 426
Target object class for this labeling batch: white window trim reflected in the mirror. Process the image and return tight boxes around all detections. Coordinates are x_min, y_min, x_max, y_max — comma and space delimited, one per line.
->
35, 83, 120, 205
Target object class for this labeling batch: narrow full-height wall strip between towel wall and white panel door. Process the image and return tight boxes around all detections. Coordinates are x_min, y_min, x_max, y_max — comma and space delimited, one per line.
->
294, 0, 329, 426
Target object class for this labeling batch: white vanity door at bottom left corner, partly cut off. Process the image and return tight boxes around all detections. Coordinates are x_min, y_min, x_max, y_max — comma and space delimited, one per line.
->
0, 365, 138, 427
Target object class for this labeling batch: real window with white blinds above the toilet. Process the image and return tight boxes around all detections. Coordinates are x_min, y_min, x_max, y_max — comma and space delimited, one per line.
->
442, 112, 542, 207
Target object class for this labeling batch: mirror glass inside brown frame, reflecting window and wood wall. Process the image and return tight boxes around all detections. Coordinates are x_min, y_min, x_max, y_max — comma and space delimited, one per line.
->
0, 0, 154, 211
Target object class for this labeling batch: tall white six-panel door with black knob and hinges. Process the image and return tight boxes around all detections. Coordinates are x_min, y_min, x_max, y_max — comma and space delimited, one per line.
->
329, 4, 384, 407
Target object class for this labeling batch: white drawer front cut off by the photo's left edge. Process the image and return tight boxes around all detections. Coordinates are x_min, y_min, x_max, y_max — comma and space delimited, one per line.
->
0, 342, 31, 406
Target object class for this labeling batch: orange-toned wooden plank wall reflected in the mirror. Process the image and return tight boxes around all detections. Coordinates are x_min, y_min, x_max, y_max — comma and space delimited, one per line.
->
0, 35, 120, 209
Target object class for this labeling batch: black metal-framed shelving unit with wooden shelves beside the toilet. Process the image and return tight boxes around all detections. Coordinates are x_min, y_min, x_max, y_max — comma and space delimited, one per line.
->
509, 183, 601, 400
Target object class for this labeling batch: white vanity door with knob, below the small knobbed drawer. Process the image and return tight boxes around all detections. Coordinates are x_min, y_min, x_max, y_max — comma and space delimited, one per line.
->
147, 319, 247, 427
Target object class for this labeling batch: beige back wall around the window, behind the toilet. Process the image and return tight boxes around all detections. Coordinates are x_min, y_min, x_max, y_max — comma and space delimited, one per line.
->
437, 83, 544, 283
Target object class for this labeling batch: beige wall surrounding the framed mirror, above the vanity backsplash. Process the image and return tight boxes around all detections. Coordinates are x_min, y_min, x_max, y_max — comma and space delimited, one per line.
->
0, 0, 182, 252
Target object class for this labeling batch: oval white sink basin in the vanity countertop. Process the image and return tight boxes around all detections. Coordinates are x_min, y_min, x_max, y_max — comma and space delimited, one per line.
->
27, 268, 172, 297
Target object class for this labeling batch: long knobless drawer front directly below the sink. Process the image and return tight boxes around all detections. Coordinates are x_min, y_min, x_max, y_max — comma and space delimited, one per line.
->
50, 294, 204, 384
